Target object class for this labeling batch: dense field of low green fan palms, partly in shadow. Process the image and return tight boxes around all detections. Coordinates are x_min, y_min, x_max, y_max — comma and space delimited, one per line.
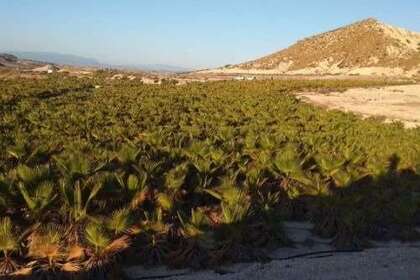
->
0, 75, 420, 279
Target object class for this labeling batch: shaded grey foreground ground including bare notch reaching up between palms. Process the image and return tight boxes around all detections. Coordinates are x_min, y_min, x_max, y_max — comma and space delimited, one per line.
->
125, 222, 420, 280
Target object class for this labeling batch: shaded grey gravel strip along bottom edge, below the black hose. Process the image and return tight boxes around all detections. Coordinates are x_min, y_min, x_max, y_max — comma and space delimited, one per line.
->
124, 246, 420, 280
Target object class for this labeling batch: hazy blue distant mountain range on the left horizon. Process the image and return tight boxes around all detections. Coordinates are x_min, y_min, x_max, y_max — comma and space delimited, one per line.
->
5, 51, 191, 72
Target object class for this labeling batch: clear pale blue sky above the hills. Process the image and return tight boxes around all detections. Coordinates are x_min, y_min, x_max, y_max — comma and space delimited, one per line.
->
0, 0, 420, 68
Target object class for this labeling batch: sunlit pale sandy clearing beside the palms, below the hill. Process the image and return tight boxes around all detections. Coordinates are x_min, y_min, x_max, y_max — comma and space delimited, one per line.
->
297, 84, 420, 128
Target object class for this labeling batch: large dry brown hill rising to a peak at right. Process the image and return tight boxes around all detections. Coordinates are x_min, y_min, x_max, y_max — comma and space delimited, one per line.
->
208, 19, 420, 76
